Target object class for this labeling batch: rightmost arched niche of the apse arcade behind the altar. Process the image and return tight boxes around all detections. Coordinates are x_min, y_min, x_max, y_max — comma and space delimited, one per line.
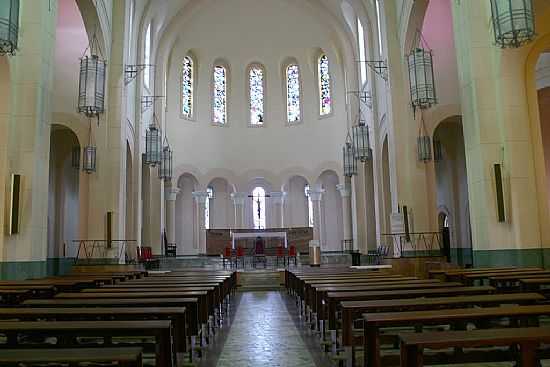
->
313, 171, 344, 251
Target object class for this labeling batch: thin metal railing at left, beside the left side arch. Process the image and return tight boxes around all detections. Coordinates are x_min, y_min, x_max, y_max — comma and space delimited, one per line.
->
72, 240, 137, 264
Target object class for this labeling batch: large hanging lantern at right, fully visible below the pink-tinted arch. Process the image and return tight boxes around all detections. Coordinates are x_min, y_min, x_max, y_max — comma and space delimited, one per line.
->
407, 40, 437, 110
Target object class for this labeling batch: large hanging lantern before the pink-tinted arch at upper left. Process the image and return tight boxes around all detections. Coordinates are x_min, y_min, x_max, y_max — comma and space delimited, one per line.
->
78, 34, 107, 117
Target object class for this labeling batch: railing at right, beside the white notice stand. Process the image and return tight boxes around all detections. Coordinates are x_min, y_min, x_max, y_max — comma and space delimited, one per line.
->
381, 232, 443, 257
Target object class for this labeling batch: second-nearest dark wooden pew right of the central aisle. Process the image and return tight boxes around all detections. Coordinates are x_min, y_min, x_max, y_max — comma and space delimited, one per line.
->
363, 305, 550, 367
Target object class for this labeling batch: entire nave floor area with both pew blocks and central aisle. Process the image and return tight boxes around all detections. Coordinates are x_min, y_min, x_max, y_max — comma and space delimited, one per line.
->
0, 265, 550, 367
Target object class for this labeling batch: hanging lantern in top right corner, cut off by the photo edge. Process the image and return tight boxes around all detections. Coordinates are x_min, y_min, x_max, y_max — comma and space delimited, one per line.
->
491, 0, 535, 48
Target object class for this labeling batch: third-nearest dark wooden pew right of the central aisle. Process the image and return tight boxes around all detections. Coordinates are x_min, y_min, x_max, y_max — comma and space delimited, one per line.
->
340, 293, 544, 366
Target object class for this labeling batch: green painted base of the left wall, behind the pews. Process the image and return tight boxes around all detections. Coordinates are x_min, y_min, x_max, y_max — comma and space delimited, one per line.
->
0, 258, 74, 280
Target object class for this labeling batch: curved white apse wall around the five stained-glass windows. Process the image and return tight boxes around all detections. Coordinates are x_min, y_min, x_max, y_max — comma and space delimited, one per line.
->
166, 0, 346, 184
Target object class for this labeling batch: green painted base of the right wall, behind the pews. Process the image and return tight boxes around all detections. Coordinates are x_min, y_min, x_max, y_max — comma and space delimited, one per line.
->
474, 248, 550, 269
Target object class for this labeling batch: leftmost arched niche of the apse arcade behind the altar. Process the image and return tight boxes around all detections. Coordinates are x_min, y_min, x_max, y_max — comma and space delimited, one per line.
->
176, 173, 200, 255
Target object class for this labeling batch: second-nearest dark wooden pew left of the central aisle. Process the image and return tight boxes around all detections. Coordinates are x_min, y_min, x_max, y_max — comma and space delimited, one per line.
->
0, 320, 176, 367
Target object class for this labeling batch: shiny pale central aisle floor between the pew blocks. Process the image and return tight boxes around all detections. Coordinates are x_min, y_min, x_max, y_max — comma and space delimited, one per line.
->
217, 292, 316, 367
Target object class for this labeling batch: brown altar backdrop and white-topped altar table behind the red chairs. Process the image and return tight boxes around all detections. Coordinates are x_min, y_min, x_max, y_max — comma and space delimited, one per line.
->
206, 227, 313, 256
